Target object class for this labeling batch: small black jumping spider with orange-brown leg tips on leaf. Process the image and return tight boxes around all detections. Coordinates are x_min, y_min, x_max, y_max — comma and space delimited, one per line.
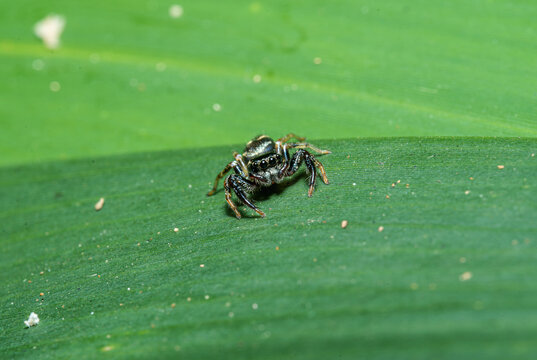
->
207, 133, 331, 219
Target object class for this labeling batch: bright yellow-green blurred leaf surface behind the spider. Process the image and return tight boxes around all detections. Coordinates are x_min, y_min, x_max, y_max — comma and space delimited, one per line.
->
0, 0, 537, 165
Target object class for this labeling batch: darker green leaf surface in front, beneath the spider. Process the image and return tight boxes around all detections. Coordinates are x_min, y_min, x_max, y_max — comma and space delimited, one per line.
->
0, 138, 537, 359
